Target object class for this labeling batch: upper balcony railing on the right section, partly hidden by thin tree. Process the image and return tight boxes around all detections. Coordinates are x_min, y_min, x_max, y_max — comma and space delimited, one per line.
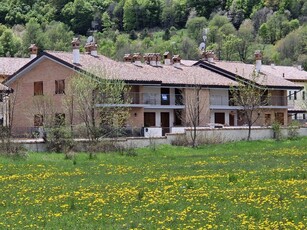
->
210, 95, 288, 106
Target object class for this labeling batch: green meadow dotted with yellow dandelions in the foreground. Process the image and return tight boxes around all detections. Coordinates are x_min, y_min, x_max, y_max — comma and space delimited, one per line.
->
0, 138, 307, 229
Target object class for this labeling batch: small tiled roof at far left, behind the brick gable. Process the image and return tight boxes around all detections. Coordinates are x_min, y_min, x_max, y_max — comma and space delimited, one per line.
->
0, 57, 31, 76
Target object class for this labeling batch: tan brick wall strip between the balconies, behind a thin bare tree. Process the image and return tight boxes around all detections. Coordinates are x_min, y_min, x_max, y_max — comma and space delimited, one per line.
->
184, 88, 210, 126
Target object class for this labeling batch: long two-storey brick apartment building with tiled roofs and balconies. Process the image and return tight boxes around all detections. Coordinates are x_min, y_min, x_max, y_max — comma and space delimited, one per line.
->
0, 39, 302, 136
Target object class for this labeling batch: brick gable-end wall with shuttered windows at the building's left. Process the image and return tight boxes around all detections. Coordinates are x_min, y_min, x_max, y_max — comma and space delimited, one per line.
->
10, 59, 74, 134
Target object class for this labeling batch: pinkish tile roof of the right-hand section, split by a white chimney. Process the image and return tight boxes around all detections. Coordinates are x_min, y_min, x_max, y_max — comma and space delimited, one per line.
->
208, 61, 307, 87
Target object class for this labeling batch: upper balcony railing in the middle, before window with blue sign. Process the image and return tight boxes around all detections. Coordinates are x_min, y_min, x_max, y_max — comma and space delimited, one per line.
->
125, 92, 183, 105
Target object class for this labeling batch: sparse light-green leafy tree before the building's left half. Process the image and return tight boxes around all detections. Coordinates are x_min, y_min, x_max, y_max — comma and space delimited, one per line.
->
65, 69, 129, 141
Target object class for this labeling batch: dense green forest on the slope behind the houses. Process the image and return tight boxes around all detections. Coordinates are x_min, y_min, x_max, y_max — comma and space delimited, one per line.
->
0, 0, 307, 70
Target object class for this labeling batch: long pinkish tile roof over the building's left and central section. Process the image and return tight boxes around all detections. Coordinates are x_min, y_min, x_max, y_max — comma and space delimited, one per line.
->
46, 52, 237, 87
